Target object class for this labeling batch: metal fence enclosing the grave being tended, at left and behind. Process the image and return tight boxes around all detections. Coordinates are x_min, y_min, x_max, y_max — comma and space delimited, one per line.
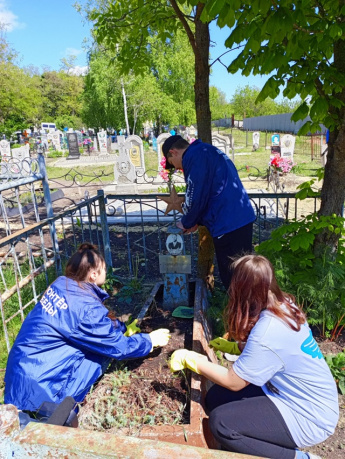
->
0, 155, 318, 360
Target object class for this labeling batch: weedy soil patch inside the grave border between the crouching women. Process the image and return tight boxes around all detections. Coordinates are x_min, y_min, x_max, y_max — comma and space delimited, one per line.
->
79, 290, 193, 436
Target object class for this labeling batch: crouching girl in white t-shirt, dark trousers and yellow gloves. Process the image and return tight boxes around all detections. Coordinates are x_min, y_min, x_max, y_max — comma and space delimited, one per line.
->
170, 255, 339, 459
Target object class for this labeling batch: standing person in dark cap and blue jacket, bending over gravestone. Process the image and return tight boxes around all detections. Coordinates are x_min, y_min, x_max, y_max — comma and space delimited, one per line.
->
162, 135, 255, 289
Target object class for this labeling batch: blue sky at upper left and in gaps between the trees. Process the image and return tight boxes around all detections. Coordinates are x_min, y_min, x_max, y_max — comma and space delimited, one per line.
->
0, 0, 267, 101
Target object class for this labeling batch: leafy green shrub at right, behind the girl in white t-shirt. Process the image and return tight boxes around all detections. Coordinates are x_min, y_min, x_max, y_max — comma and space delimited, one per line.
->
256, 213, 345, 340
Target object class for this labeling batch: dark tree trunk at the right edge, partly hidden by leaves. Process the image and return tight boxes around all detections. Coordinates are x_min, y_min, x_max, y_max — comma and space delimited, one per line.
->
314, 40, 345, 253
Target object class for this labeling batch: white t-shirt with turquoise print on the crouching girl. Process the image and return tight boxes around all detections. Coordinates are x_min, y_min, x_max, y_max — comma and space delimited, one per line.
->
233, 311, 339, 448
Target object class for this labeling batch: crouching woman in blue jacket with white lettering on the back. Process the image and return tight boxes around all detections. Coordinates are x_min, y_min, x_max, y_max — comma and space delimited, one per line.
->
5, 243, 170, 411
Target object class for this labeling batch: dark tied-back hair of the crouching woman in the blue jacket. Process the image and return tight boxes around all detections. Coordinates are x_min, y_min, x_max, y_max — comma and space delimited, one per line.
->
65, 242, 105, 282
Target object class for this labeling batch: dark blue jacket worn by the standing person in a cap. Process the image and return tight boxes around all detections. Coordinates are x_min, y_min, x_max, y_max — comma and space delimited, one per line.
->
181, 140, 255, 237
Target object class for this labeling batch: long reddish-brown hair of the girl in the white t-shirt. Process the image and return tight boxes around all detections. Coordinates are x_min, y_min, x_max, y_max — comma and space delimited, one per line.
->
225, 255, 306, 341
